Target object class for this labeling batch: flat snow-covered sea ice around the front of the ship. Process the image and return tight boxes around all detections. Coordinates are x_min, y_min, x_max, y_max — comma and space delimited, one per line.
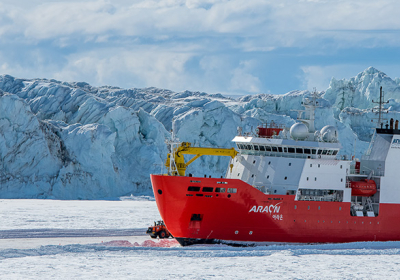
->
0, 199, 400, 279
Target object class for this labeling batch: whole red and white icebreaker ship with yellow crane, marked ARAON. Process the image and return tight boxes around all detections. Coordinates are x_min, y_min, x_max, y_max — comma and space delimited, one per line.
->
151, 88, 400, 246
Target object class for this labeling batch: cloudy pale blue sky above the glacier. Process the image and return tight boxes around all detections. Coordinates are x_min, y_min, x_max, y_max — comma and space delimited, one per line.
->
0, 0, 400, 95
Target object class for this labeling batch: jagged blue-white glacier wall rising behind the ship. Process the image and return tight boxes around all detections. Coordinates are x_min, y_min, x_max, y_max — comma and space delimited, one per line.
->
0, 67, 400, 199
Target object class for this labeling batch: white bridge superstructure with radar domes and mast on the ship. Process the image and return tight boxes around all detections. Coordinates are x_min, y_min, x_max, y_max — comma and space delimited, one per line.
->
226, 93, 351, 201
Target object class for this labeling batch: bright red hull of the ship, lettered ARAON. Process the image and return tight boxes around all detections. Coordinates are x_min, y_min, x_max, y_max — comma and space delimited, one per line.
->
151, 175, 400, 245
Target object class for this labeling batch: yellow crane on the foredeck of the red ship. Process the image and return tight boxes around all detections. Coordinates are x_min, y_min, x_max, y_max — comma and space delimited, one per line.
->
165, 142, 238, 176
